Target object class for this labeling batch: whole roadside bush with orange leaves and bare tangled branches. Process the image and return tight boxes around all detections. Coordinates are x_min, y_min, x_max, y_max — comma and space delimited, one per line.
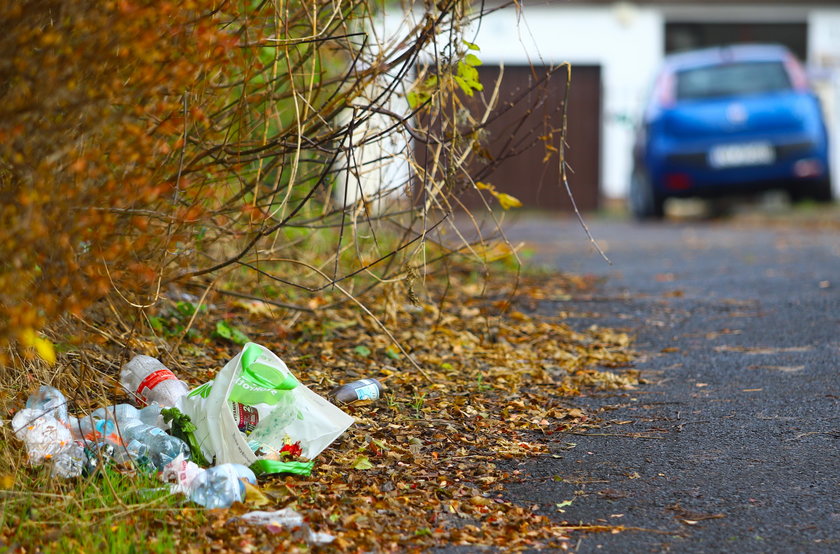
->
0, 0, 532, 365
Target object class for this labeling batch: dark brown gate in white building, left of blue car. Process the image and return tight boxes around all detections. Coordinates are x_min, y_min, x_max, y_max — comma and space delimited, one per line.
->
452, 66, 601, 211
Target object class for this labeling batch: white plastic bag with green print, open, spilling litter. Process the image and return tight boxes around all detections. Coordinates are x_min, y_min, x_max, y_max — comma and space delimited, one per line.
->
181, 342, 353, 466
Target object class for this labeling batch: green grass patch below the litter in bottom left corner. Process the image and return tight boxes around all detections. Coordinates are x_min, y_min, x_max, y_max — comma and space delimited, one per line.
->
0, 438, 206, 553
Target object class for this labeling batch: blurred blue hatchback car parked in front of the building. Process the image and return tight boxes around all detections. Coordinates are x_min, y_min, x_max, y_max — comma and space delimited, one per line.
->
629, 44, 832, 219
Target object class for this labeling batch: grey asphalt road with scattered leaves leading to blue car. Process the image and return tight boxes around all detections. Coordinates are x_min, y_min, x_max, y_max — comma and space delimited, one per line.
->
498, 208, 840, 553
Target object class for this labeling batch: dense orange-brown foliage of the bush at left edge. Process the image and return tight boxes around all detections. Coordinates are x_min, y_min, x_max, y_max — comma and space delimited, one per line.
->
0, 0, 243, 360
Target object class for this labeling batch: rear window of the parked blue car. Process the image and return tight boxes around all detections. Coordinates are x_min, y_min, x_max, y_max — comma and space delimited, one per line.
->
676, 62, 791, 100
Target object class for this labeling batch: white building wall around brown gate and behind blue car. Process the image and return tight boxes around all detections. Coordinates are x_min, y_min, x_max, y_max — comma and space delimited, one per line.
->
380, 1, 840, 203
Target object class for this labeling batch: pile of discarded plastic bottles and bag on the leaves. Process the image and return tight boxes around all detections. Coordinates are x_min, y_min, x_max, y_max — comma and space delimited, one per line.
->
12, 343, 360, 544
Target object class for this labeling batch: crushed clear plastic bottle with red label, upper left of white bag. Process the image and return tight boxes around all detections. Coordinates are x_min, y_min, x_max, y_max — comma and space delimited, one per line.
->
120, 354, 189, 408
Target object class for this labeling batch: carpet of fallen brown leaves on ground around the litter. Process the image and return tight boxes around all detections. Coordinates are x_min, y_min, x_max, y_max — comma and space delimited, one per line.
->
0, 264, 638, 551
